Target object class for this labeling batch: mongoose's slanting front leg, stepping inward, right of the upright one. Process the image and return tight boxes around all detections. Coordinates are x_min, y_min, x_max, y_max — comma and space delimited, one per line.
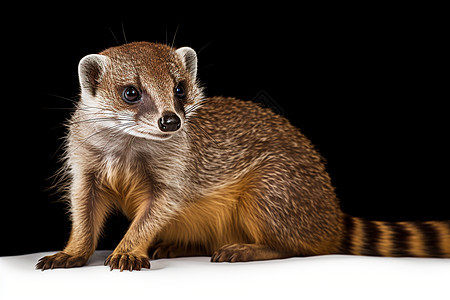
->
105, 193, 178, 271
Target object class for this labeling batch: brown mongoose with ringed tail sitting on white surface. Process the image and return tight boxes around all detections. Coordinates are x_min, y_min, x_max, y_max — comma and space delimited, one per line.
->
36, 42, 450, 271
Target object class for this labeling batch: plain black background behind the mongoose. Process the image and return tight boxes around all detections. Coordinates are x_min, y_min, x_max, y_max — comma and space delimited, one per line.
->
0, 3, 450, 255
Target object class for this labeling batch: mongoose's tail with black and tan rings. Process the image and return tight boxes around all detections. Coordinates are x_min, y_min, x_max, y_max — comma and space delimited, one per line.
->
341, 215, 450, 257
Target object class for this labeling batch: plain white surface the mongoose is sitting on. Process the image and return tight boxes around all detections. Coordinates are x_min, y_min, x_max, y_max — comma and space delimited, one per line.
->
0, 251, 450, 300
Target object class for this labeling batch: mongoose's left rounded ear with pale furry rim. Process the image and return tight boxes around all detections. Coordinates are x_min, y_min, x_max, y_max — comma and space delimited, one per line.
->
78, 54, 110, 96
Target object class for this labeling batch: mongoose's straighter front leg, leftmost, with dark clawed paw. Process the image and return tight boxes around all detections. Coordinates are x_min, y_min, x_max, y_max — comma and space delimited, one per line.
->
36, 170, 110, 271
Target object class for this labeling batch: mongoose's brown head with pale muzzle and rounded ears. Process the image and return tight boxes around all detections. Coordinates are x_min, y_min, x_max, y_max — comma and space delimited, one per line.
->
78, 42, 203, 140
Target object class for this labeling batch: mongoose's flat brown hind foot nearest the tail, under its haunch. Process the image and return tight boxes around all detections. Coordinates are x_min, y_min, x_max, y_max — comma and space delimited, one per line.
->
211, 244, 293, 262
